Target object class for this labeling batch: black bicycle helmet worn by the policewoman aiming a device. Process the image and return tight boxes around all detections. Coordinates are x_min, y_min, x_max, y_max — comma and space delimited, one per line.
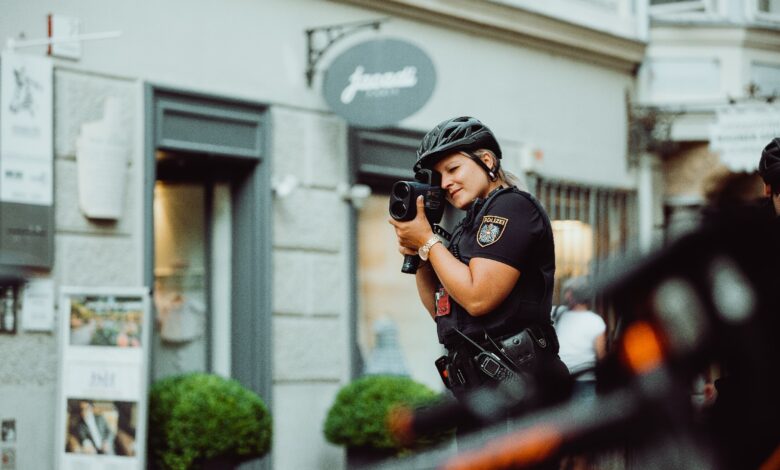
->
414, 116, 501, 173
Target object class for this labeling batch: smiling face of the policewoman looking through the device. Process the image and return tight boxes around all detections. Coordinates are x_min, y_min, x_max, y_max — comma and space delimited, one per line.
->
433, 152, 494, 210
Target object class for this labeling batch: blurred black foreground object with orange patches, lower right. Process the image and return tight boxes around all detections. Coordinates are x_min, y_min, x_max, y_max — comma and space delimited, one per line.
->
377, 210, 780, 470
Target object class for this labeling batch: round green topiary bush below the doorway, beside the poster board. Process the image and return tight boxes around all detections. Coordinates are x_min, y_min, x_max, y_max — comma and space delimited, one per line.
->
149, 373, 272, 470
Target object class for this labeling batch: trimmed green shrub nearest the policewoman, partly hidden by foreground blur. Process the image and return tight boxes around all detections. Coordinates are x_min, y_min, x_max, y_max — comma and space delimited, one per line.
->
324, 375, 443, 451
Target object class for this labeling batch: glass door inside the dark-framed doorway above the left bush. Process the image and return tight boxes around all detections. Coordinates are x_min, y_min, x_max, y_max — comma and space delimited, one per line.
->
152, 154, 232, 380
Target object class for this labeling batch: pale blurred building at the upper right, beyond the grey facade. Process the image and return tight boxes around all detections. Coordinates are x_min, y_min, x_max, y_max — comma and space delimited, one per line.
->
638, 0, 780, 235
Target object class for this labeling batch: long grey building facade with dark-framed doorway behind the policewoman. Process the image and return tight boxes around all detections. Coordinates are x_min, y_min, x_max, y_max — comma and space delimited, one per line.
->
0, 0, 652, 469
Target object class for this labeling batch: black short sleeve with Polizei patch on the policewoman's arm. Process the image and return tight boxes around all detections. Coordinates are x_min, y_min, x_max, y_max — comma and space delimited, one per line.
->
472, 193, 545, 271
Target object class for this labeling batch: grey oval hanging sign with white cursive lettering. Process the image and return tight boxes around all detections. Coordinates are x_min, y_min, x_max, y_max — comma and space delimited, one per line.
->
323, 39, 436, 128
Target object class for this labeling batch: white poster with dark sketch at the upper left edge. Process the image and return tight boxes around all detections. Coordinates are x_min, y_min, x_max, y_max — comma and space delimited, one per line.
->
0, 52, 54, 205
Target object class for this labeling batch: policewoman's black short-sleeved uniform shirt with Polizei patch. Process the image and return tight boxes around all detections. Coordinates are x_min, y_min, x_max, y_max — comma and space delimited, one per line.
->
436, 188, 555, 346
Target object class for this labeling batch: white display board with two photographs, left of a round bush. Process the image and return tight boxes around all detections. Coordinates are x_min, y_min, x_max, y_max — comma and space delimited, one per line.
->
55, 287, 151, 470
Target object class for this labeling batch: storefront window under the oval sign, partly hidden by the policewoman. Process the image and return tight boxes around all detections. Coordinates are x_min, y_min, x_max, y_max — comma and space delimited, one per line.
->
350, 130, 443, 390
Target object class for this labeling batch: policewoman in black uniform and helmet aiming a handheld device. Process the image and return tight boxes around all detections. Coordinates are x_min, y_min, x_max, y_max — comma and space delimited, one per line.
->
390, 117, 568, 424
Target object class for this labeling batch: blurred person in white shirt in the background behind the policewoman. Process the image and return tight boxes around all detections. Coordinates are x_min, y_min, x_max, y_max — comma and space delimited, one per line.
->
555, 277, 607, 399
